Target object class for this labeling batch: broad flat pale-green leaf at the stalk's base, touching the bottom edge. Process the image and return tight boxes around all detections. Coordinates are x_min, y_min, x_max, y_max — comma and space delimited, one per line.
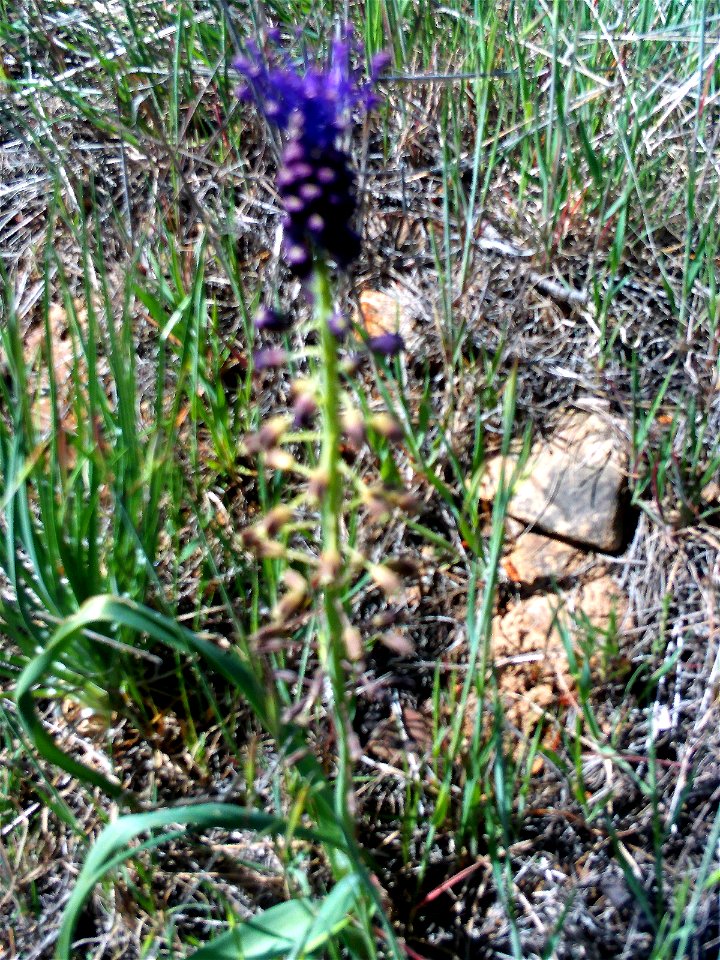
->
188, 874, 359, 960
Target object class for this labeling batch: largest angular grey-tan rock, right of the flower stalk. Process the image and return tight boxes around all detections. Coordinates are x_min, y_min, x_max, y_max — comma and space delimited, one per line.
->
481, 413, 627, 551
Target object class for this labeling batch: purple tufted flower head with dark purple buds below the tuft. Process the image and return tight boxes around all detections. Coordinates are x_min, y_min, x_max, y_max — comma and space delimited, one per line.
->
236, 30, 386, 278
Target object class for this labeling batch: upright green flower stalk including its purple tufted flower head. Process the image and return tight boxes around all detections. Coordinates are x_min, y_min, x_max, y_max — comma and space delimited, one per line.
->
237, 32, 402, 892
